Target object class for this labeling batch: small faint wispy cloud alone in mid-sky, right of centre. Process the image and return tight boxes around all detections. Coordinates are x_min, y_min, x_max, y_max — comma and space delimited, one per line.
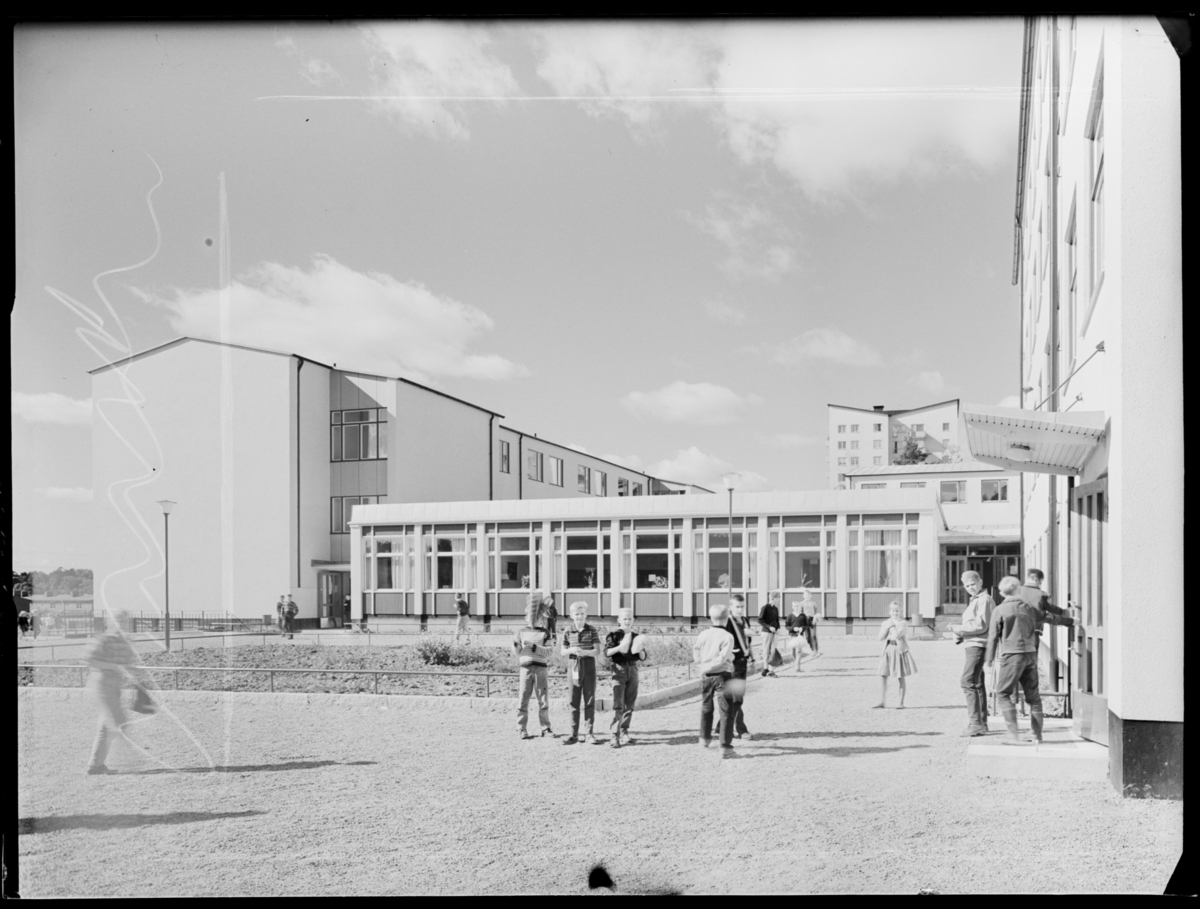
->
685, 197, 796, 282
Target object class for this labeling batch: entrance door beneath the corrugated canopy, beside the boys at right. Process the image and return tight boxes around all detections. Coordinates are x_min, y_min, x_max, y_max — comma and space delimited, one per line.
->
1069, 478, 1109, 745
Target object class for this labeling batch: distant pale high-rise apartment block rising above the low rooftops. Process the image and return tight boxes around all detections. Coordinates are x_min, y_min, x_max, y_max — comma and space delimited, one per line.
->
827, 398, 959, 489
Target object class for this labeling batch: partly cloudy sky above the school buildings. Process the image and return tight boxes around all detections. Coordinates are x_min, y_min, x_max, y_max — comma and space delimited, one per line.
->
11, 18, 1022, 571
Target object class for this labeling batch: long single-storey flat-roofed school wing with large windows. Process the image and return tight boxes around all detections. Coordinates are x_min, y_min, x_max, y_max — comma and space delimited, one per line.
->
349, 489, 941, 631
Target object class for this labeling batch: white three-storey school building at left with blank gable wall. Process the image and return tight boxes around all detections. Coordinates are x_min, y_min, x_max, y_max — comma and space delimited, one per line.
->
98, 338, 710, 625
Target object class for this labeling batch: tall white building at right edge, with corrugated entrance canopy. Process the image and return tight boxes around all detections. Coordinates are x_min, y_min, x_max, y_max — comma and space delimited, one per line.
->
962, 17, 1188, 799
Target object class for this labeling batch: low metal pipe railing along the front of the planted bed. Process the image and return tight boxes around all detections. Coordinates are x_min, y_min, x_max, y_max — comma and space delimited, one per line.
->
17, 663, 692, 698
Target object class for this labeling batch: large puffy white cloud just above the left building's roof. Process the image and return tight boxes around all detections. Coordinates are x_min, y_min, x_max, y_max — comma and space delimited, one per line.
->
134, 255, 528, 381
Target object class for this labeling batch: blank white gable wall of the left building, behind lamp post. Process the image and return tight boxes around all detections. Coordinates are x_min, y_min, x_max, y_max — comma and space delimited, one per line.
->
92, 341, 295, 615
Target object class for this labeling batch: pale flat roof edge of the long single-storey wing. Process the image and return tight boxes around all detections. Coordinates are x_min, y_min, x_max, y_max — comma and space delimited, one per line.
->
348, 489, 937, 525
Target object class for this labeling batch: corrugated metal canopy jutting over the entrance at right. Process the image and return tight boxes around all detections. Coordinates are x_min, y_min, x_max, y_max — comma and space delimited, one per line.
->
962, 404, 1106, 476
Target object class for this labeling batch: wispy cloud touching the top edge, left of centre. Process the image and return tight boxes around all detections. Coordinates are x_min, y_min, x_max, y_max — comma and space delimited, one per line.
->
361, 22, 520, 139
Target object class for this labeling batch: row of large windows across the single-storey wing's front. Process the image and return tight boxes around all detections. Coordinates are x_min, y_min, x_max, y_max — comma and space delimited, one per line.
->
364, 514, 918, 591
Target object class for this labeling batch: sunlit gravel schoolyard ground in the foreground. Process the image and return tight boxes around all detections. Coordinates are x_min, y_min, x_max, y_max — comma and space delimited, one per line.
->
18, 636, 1182, 897
